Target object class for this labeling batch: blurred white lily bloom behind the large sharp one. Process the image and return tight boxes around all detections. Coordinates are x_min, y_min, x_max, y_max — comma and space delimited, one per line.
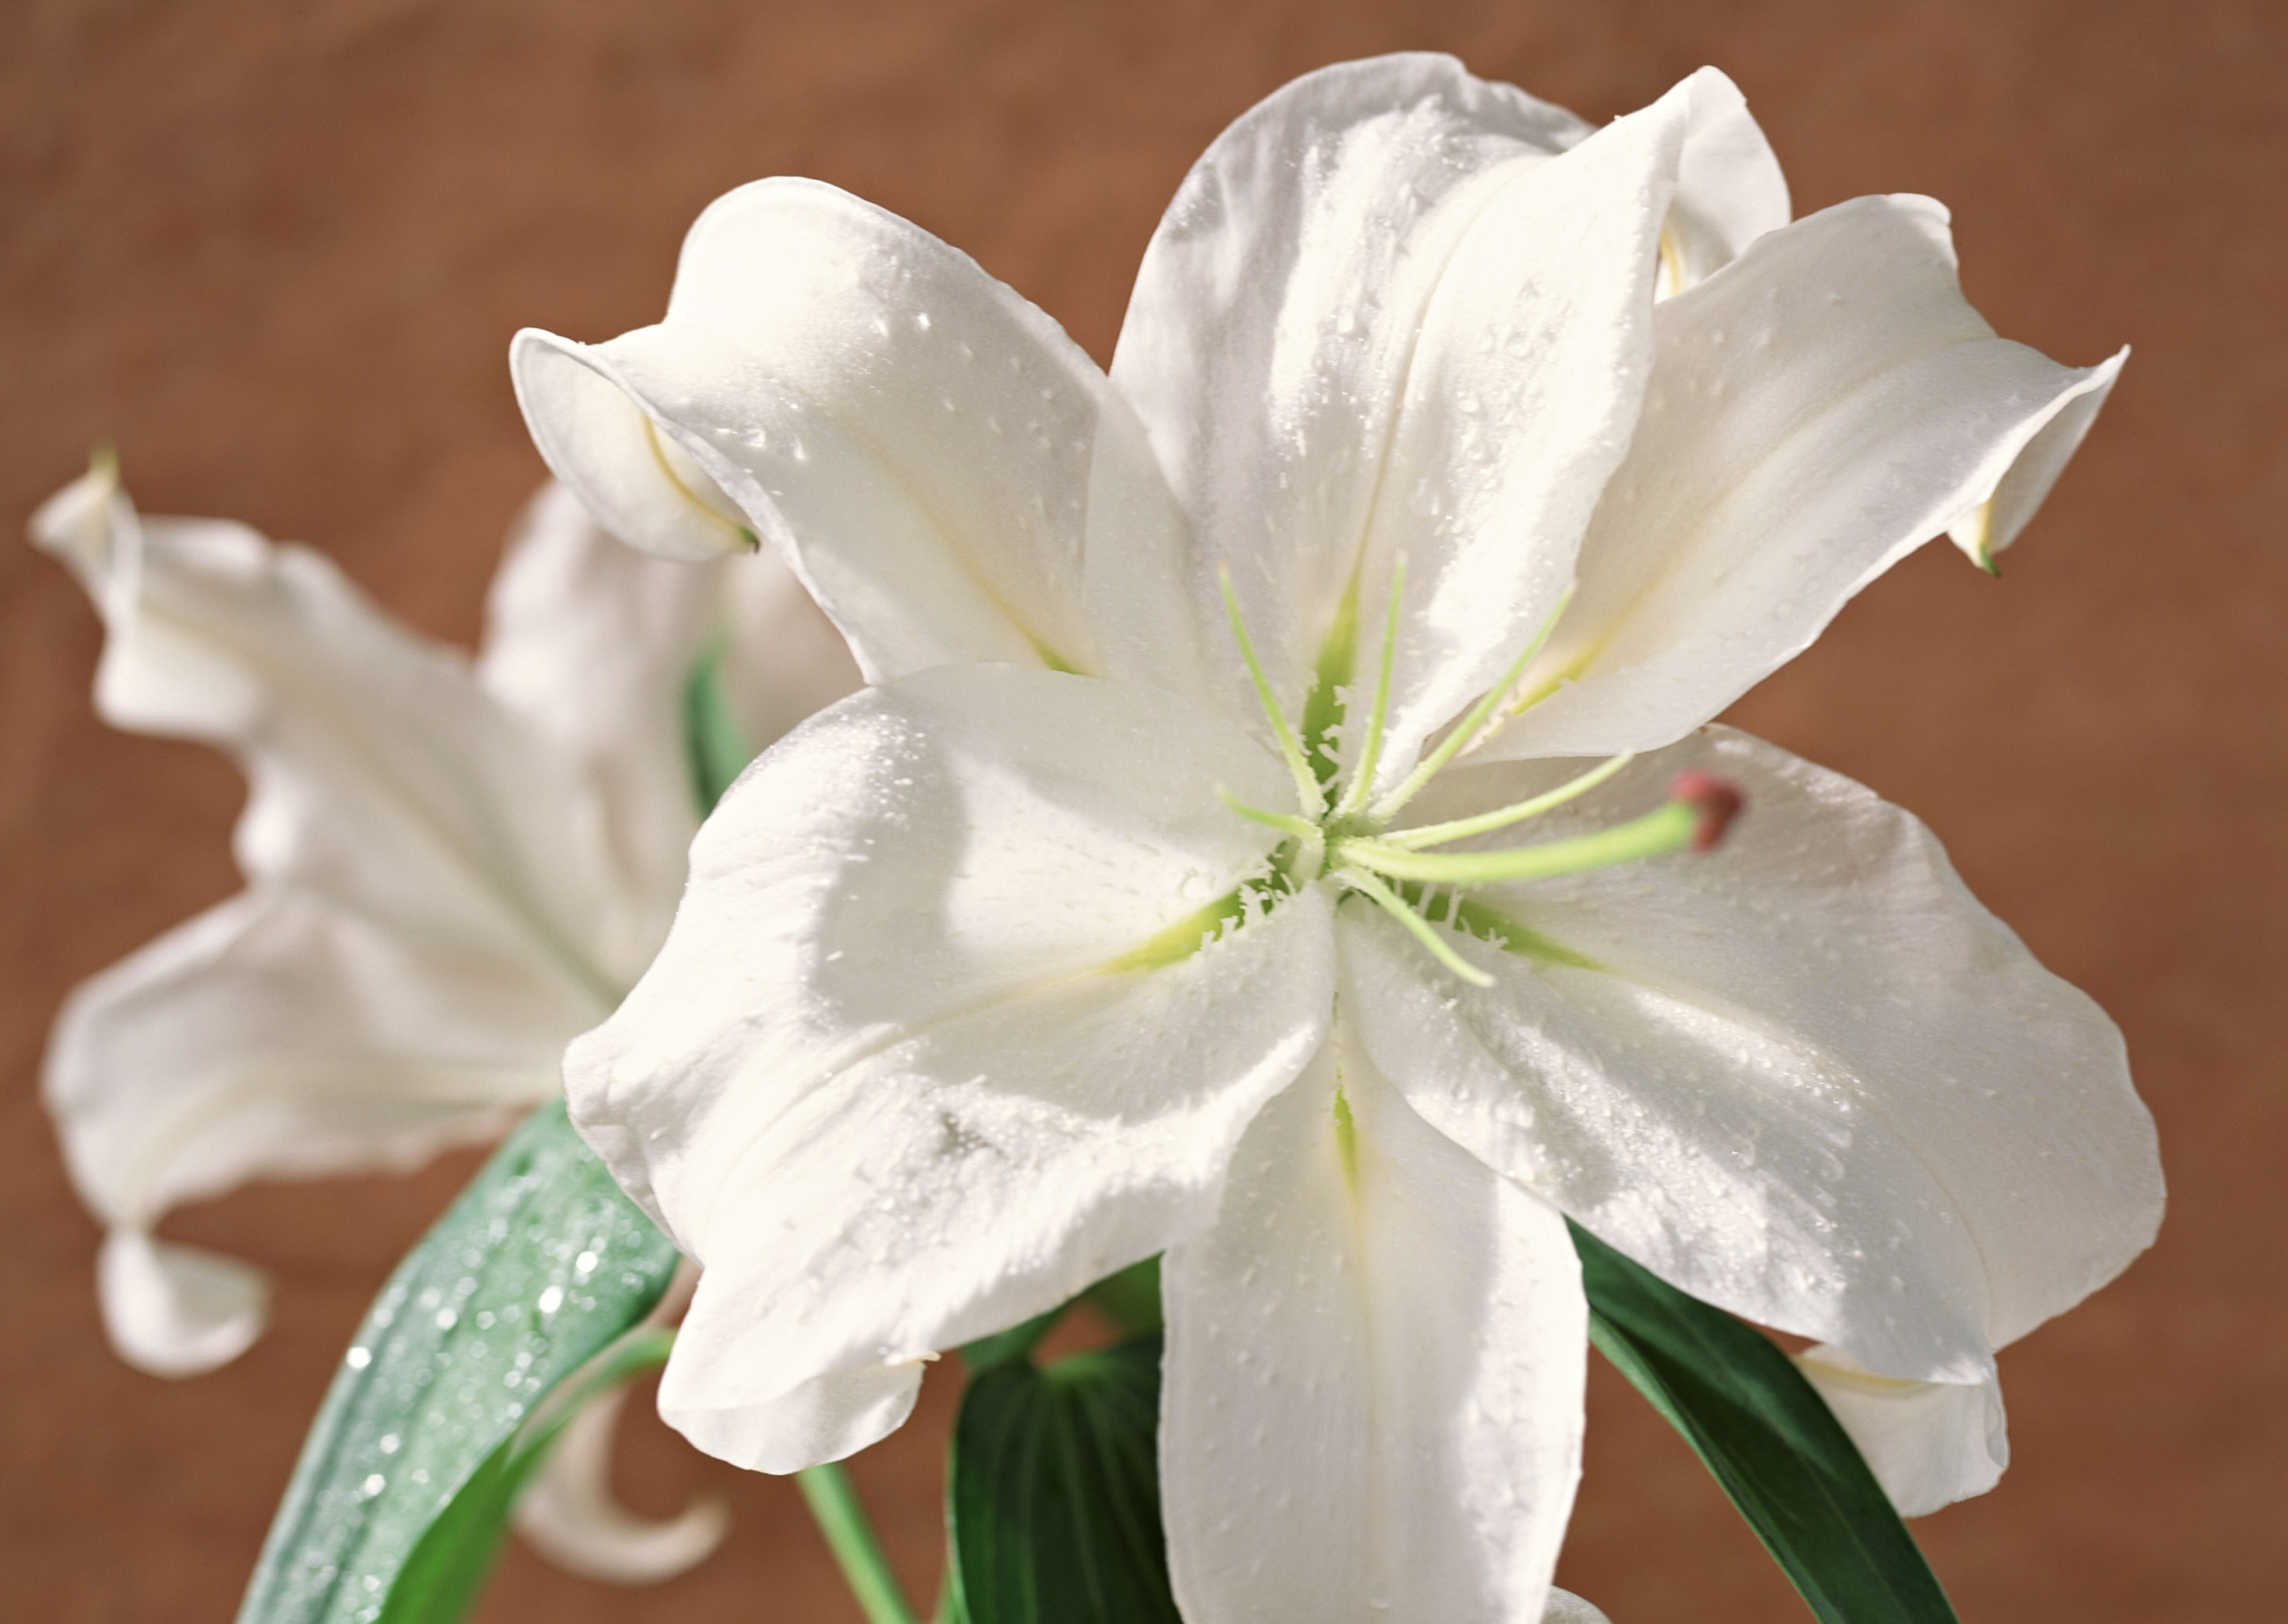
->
32, 467, 855, 1574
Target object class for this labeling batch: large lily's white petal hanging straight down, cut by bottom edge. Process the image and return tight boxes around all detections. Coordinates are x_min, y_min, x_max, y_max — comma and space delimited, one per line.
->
1160, 1038, 1588, 1624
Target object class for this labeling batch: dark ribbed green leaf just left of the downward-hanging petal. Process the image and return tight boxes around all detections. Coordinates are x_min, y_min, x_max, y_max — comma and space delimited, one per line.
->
945, 1331, 1180, 1624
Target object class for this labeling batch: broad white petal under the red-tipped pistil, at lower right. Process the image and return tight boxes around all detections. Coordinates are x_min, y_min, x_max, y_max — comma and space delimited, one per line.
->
1339, 730, 2160, 1384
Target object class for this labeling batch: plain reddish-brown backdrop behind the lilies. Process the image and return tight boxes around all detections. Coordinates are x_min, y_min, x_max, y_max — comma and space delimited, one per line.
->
0, 0, 2288, 1624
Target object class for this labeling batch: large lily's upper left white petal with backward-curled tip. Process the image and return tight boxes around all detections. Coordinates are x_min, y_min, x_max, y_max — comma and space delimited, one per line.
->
510, 178, 1197, 686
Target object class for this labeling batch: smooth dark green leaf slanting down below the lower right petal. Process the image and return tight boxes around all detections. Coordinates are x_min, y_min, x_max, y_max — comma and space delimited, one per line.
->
1572, 1226, 1954, 1624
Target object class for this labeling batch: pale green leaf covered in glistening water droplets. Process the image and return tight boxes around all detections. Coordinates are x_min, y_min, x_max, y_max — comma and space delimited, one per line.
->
238, 1101, 675, 1624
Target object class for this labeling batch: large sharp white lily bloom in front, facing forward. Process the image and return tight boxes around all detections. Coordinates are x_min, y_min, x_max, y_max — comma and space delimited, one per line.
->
515, 55, 2160, 1624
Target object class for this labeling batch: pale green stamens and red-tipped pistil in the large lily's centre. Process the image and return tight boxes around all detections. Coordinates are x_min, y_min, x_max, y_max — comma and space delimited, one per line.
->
1217, 556, 1741, 986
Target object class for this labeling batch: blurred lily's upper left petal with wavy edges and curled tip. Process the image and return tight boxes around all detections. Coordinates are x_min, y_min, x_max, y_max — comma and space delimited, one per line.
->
32, 474, 616, 1009
